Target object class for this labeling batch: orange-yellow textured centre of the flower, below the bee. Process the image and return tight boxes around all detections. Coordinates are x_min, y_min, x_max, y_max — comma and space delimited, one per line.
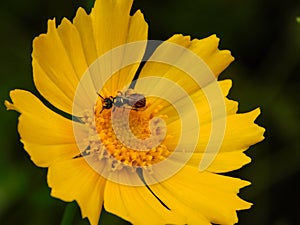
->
88, 98, 171, 169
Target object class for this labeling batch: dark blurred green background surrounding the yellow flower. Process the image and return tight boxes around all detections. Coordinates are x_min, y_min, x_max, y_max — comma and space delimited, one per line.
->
0, 0, 300, 225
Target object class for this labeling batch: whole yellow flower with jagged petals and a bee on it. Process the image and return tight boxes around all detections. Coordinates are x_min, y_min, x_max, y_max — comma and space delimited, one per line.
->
5, 0, 264, 225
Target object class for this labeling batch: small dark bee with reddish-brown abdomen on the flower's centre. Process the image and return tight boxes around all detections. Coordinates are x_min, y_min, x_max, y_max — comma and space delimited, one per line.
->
97, 89, 146, 113
